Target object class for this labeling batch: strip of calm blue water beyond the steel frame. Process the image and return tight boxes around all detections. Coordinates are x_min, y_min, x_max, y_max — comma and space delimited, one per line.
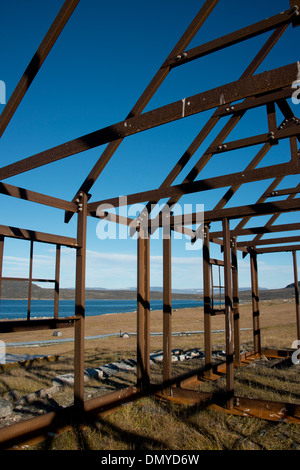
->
0, 299, 203, 320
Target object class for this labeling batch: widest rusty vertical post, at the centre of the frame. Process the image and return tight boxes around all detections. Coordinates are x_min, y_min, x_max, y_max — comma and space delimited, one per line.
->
137, 228, 150, 390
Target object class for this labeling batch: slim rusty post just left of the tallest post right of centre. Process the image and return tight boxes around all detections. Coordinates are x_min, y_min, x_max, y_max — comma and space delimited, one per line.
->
203, 224, 212, 376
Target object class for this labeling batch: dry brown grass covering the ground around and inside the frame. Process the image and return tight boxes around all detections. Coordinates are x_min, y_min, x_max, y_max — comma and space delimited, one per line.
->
0, 300, 300, 450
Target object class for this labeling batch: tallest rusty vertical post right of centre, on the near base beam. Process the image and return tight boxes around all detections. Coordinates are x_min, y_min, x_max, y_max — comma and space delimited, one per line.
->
222, 218, 234, 409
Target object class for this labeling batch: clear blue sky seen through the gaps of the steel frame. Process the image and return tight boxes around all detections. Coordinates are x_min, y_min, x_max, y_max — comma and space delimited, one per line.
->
0, 0, 300, 288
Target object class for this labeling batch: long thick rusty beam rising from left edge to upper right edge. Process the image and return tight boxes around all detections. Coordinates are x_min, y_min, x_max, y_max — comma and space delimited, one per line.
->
0, 63, 298, 179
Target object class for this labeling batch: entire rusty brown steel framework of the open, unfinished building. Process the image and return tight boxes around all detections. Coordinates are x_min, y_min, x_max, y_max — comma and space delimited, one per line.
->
0, 0, 300, 447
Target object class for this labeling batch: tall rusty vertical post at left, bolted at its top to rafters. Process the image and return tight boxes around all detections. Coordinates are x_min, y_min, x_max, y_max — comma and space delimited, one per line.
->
74, 193, 87, 411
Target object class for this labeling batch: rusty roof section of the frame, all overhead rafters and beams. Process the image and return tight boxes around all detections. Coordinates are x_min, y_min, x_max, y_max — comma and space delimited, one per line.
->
0, 0, 300, 253
